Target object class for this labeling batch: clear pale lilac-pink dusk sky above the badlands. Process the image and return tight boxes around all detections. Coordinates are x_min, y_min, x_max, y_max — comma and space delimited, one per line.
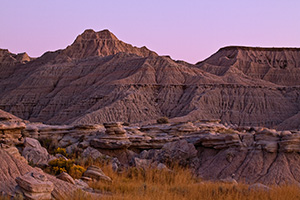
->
0, 0, 300, 63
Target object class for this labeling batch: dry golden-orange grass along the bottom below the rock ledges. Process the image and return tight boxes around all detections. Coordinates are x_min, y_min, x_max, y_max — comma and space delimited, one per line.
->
86, 166, 300, 200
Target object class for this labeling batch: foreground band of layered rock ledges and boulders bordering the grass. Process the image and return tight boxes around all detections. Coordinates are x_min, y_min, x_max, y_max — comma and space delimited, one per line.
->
0, 111, 300, 199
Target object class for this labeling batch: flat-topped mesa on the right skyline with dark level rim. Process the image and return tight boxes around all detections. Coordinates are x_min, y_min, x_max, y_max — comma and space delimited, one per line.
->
197, 46, 300, 86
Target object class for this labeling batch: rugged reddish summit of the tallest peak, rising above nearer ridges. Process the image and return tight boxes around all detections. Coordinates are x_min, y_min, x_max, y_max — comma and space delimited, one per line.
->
64, 29, 157, 59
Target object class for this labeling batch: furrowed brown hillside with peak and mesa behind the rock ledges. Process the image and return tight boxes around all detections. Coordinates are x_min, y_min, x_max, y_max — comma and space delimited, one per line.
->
0, 30, 300, 129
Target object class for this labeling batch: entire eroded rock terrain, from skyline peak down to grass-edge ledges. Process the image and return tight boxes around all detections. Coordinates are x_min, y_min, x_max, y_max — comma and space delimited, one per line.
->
0, 30, 300, 199
